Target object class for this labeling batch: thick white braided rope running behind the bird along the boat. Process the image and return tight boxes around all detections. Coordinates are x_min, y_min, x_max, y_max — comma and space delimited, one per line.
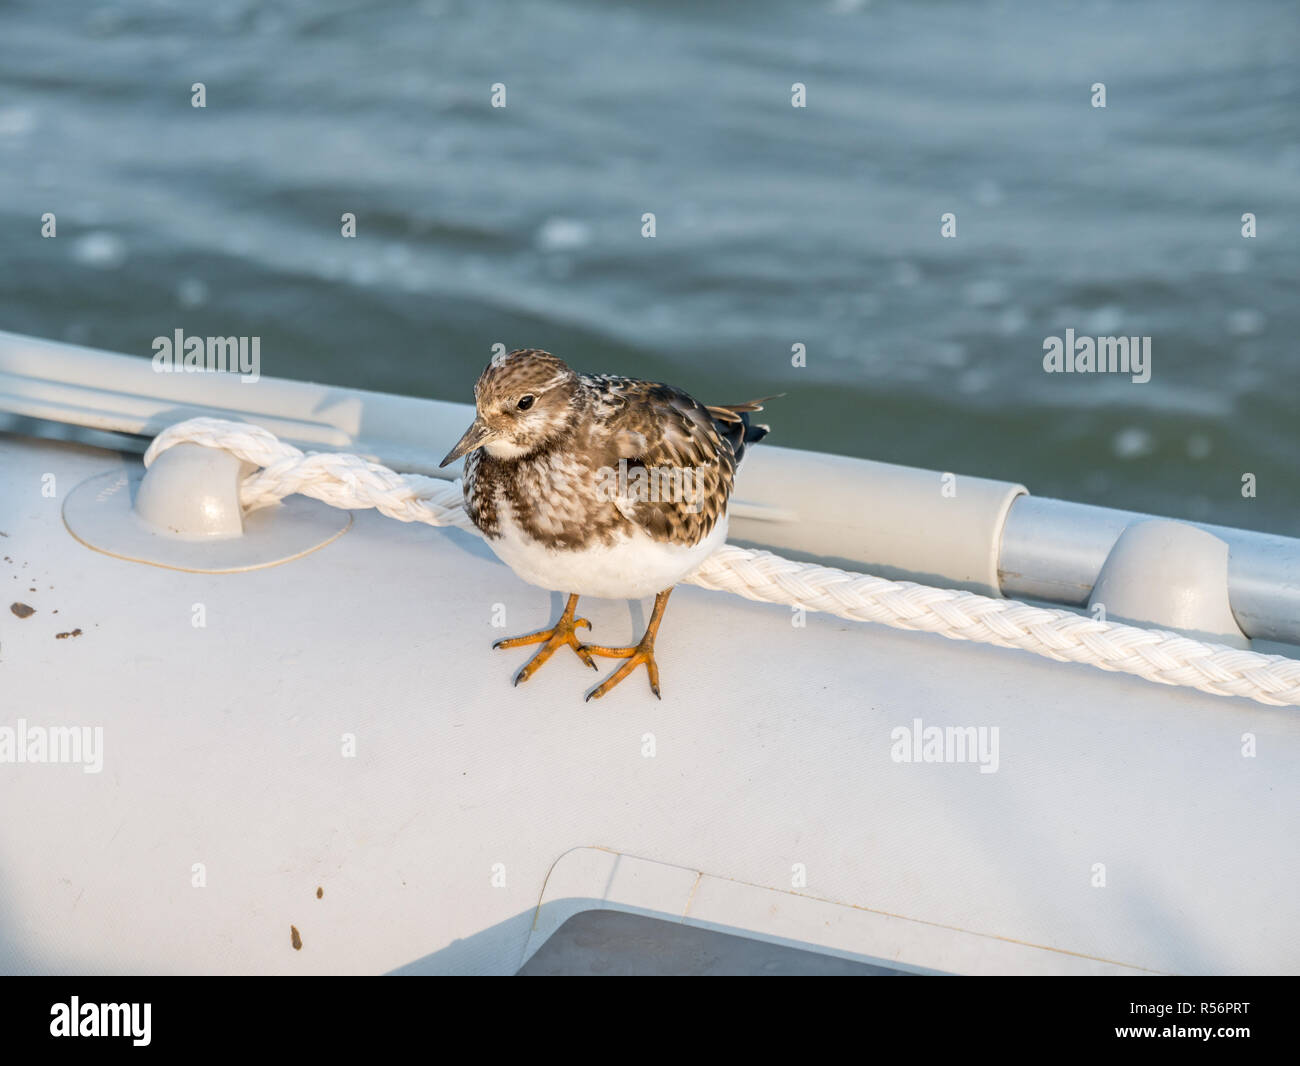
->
144, 419, 1300, 706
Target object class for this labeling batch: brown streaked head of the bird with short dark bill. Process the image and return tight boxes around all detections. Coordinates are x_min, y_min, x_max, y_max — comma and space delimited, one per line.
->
438, 348, 577, 467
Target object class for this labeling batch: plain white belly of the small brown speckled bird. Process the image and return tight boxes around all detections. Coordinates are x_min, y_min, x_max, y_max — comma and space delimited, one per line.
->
488, 507, 727, 599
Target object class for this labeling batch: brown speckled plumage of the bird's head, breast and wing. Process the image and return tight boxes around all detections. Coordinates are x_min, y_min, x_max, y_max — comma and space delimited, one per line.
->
464, 348, 767, 550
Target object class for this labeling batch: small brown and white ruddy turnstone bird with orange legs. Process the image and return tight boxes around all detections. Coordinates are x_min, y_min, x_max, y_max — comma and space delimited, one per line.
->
441, 348, 767, 699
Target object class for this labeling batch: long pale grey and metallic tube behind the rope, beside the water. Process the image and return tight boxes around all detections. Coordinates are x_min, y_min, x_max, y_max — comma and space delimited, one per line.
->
0, 325, 1300, 645
